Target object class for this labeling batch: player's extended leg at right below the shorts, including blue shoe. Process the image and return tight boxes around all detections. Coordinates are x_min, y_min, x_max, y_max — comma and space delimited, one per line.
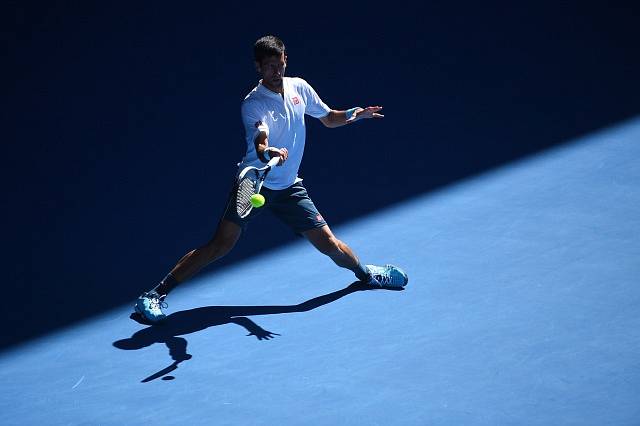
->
303, 225, 408, 287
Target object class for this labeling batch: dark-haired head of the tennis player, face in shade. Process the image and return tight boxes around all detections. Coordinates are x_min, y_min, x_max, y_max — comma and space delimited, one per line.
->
253, 35, 287, 91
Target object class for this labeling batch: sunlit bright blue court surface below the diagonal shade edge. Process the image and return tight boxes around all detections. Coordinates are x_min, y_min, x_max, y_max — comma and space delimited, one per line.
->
0, 120, 640, 425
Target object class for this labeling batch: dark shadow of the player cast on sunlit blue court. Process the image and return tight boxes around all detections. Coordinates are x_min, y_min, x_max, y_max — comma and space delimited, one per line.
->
113, 281, 398, 382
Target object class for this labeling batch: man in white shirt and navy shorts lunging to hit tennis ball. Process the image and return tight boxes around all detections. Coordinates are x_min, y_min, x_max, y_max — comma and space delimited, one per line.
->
135, 36, 408, 322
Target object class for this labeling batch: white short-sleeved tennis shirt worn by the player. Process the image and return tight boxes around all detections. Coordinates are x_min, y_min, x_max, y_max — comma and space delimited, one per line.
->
238, 77, 331, 189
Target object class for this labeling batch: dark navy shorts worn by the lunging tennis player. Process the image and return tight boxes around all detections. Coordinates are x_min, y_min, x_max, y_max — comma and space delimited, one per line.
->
223, 182, 327, 234
